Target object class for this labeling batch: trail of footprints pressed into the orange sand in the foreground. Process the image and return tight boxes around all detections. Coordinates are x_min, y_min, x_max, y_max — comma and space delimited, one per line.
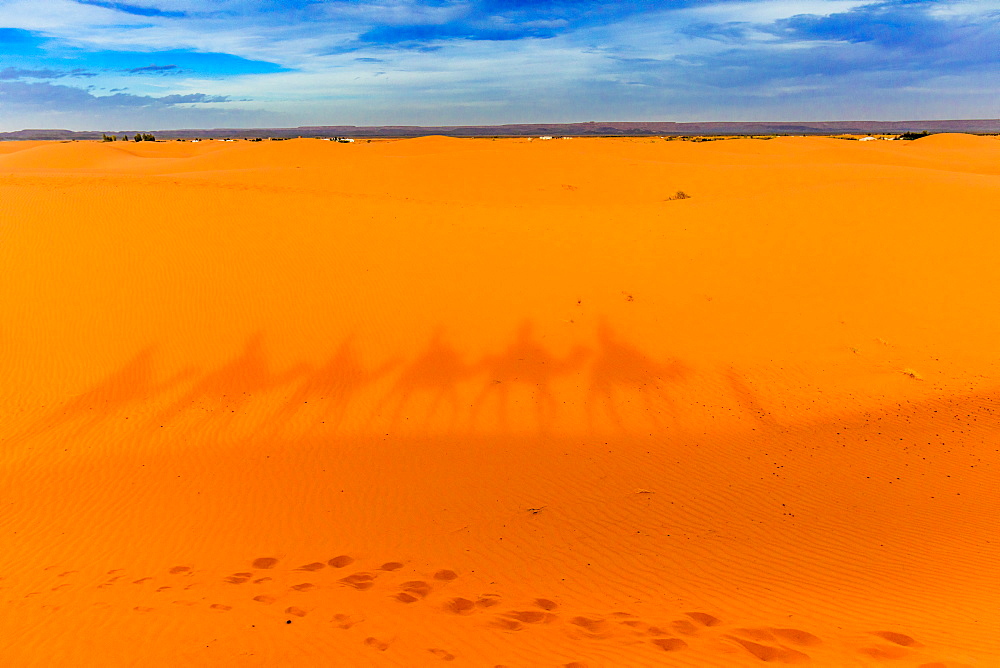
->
28, 555, 952, 668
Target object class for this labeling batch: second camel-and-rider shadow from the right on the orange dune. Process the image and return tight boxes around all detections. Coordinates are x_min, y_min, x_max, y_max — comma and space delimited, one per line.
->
469, 320, 590, 433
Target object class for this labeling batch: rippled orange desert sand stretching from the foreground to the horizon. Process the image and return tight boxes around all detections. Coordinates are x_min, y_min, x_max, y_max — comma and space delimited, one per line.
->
0, 134, 1000, 668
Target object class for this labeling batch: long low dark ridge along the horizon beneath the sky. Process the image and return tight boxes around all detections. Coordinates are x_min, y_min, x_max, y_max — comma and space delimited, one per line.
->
0, 119, 1000, 140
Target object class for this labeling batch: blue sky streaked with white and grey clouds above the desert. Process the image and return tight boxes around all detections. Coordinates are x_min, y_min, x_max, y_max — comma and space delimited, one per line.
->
0, 0, 1000, 130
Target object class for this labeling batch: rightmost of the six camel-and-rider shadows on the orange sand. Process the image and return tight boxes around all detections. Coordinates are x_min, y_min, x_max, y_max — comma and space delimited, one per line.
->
585, 320, 690, 432
